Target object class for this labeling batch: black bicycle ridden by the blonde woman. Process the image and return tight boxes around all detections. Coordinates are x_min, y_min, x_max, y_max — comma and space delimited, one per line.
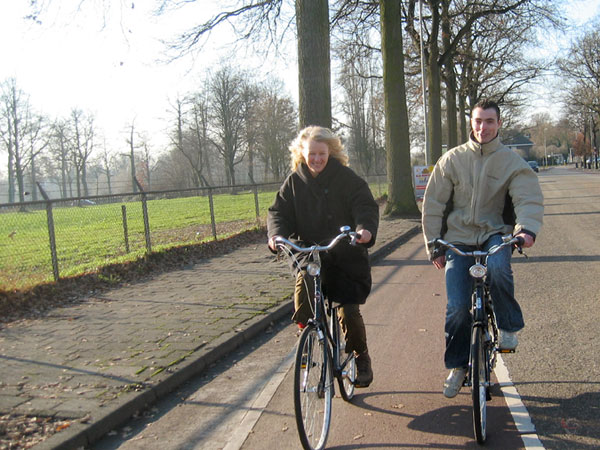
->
275, 226, 357, 450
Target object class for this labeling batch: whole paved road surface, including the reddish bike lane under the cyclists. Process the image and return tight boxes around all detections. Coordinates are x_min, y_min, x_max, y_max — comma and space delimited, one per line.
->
94, 167, 600, 450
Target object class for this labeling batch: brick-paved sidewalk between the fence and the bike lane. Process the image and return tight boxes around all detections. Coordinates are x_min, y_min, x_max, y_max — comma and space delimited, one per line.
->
0, 219, 419, 449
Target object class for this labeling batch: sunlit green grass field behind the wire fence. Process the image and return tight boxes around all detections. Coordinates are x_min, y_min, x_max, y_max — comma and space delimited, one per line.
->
0, 192, 275, 290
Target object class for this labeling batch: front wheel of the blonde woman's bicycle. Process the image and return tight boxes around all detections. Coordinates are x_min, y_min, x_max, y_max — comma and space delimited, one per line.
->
294, 325, 333, 450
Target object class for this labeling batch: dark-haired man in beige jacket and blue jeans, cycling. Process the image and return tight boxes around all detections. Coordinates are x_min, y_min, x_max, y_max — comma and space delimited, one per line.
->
422, 100, 544, 398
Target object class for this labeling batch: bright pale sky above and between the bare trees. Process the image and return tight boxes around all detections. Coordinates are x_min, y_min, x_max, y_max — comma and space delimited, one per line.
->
0, 0, 600, 158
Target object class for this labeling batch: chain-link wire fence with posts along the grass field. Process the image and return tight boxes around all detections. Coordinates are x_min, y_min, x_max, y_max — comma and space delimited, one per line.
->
0, 176, 386, 290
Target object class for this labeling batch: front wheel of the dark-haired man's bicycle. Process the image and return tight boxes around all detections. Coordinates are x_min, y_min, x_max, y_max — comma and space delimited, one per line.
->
471, 327, 489, 444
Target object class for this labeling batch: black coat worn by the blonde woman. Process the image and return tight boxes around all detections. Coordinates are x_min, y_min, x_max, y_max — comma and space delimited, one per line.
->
267, 158, 379, 304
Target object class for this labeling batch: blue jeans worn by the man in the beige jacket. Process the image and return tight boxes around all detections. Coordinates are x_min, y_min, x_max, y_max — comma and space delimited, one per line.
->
444, 235, 524, 369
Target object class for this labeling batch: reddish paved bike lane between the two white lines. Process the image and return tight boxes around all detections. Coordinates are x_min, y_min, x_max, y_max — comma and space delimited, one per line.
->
241, 232, 540, 450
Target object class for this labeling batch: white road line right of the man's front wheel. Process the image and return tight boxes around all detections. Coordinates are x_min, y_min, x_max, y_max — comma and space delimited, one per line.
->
494, 355, 544, 450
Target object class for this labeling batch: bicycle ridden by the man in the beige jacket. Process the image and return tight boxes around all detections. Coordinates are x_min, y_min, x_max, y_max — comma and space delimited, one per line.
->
428, 235, 523, 444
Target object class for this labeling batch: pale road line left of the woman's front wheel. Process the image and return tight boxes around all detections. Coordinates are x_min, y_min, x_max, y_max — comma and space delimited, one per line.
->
223, 346, 296, 450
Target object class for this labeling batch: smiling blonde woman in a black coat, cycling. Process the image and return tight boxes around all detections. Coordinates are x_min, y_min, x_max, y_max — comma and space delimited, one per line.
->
267, 126, 379, 387
